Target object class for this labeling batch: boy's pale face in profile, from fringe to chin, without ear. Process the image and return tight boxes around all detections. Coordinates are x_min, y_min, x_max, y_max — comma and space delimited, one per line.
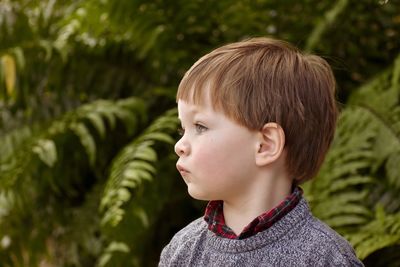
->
175, 97, 258, 201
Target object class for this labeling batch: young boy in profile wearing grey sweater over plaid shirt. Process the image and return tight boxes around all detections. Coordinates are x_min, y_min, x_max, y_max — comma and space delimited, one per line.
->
159, 38, 363, 266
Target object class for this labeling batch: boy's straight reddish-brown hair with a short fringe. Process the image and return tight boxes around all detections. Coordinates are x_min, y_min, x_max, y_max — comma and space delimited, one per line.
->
177, 38, 338, 183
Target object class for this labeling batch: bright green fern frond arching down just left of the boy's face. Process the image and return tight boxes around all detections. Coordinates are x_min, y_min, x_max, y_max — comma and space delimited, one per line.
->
99, 109, 178, 266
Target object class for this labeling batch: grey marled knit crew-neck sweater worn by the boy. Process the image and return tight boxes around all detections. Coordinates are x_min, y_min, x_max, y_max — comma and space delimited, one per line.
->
159, 199, 363, 267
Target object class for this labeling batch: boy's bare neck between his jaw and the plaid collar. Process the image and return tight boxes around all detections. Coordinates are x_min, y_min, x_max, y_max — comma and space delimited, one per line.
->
223, 171, 293, 235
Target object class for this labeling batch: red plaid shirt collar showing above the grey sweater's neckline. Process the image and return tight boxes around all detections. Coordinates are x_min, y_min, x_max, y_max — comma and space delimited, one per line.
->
204, 187, 303, 239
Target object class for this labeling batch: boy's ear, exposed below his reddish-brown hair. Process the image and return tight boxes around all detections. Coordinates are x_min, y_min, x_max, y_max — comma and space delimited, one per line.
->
256, 122, 285, 166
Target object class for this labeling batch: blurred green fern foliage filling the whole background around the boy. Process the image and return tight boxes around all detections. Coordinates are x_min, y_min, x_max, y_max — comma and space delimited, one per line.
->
0, 0, 400, 266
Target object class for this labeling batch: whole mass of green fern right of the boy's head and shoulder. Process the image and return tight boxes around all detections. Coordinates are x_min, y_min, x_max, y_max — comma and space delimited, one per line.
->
305, 52, 400, 259
